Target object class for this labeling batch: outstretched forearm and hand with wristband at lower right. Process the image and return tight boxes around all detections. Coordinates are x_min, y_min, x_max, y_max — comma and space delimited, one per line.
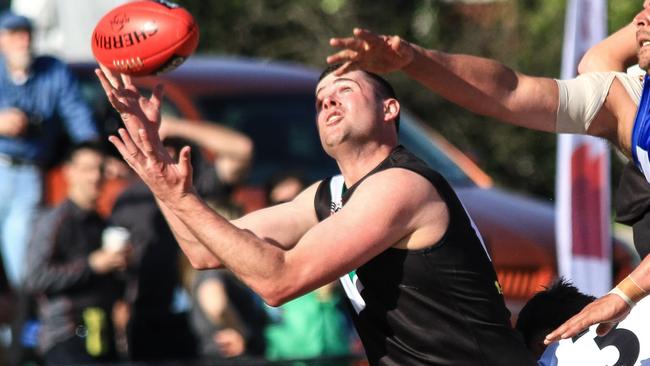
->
544, 256, 650, 344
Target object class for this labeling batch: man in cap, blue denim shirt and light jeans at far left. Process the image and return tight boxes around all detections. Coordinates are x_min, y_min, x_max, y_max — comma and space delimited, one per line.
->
0, 11, 99, 288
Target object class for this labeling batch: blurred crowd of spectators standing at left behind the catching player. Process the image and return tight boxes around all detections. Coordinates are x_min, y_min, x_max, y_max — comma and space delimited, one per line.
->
0, 7, 358, 365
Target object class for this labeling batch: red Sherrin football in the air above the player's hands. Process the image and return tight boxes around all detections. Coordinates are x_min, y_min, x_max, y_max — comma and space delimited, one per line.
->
91, 0, 199, 76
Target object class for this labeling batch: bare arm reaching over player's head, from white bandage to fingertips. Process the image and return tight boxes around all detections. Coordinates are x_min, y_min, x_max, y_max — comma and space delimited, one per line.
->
327, 28, 558, 132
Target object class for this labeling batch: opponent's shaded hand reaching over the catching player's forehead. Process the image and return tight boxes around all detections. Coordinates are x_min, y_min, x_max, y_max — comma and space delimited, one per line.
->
327, 28, 414, 75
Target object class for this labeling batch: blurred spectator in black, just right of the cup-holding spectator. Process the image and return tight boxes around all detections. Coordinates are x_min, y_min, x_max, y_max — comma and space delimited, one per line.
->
110, 142, 196, 361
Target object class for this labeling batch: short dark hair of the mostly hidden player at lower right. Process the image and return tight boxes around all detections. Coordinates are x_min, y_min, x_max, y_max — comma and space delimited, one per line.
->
515, 278, 596, 345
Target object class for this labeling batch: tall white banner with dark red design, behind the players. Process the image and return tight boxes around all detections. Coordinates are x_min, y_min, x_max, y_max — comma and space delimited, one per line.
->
555, 0, 612, 296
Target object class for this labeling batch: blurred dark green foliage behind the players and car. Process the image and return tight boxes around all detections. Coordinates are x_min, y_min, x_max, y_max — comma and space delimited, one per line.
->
178, 0, 642, 197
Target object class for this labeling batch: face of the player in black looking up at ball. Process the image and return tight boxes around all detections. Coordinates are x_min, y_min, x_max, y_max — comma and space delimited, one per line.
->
316, 70, 382, 151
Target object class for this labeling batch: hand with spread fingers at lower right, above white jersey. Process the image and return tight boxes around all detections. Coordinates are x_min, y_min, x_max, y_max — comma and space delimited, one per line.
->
544, 294, 631, 345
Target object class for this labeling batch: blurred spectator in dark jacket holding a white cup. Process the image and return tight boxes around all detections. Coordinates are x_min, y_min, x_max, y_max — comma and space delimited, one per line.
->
25, 143, 124, 365
